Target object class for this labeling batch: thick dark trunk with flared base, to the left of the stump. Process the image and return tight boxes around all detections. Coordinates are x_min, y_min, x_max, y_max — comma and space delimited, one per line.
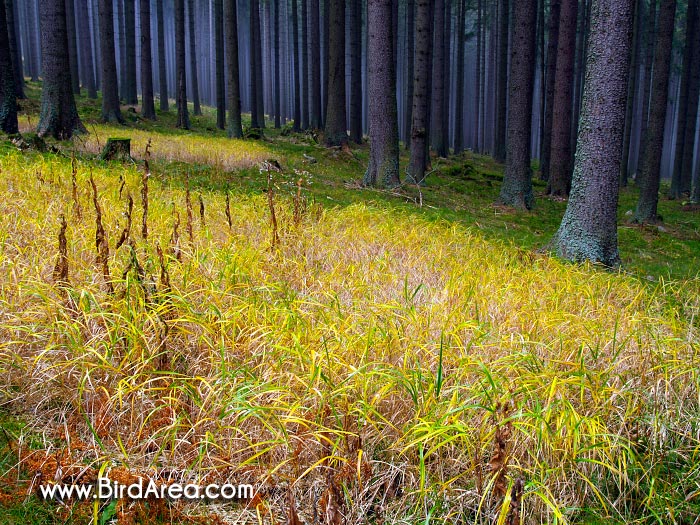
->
37, 0, 85, 140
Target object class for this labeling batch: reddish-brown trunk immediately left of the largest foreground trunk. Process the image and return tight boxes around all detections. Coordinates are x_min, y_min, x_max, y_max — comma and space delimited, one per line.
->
549, 0, 578, 197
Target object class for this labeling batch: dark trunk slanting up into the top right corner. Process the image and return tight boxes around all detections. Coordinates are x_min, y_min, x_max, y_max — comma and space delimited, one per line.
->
670, 0, 700, 199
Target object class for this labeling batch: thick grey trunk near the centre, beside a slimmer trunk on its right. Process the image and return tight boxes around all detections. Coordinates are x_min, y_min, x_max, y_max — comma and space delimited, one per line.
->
363, 0, 400, 188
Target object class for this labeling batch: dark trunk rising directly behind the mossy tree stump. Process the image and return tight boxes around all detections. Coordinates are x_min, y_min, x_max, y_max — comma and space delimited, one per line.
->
99, 0, 124, 123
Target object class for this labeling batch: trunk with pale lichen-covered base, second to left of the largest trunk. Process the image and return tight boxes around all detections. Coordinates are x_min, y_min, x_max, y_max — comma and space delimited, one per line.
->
498, 0, 537, 209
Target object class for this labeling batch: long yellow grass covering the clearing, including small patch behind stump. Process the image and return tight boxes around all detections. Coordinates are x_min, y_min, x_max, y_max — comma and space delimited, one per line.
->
0, 144, 700, 523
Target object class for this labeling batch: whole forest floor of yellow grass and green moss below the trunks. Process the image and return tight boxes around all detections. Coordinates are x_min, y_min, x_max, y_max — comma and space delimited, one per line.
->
0, 83, 700, 525
